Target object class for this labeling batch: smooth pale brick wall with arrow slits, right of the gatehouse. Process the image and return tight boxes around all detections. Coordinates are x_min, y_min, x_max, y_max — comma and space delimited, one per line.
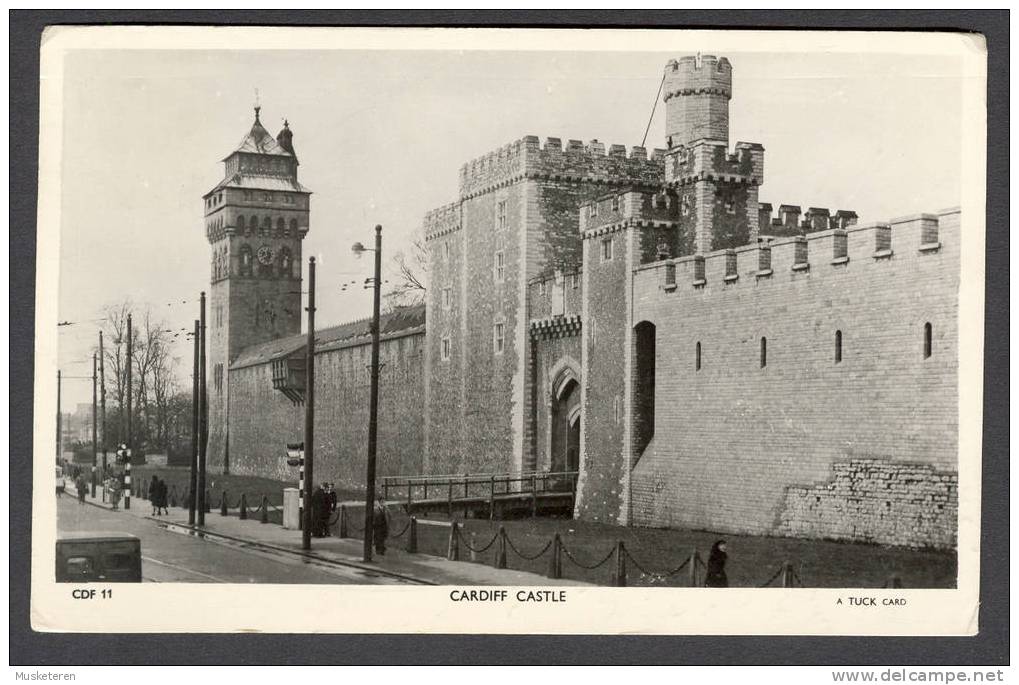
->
619, 211, 959, 546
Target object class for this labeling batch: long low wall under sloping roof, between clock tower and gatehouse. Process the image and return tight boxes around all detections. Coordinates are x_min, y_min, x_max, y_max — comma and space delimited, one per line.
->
230, 331, 425, 488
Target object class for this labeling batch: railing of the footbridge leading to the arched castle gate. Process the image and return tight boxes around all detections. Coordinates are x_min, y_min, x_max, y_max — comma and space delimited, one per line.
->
381, 471, 579, 505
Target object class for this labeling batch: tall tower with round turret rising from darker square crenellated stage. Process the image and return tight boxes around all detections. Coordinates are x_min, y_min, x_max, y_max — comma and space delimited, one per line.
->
662, 55, 764, 254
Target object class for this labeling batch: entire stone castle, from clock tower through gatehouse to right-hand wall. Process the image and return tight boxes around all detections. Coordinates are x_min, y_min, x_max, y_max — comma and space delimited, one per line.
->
206, 55, 960, 547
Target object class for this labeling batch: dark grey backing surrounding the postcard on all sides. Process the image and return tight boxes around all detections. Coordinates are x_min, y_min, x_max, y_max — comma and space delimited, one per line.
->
9, 10, 1009, 665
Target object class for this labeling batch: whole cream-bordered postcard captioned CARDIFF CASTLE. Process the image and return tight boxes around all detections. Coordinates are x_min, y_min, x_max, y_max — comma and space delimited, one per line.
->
32, 25, 986, 635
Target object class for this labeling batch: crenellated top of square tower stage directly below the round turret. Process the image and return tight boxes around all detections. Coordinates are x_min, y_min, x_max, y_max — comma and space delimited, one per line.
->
665, 139, 764, 186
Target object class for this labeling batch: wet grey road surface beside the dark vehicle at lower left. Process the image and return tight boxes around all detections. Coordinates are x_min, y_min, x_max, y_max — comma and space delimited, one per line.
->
57, 495, 415, 585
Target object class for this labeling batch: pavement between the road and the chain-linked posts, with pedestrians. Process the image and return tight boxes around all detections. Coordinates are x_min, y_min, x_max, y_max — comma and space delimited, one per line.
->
66, 483, 588, 586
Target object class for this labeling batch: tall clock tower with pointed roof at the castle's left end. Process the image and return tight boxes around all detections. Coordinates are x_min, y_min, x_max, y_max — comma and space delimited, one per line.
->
203, 107, 311, 472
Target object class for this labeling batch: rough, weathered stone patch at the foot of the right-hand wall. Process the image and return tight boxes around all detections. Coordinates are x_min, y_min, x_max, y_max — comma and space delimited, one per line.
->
777, 459, 959, 547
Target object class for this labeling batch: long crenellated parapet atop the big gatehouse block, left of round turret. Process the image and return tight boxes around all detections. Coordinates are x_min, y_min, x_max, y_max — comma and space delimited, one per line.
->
460, 136, 665, 199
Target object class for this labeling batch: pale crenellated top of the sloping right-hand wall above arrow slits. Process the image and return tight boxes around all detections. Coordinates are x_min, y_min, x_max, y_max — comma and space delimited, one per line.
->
634, 208, 960, 293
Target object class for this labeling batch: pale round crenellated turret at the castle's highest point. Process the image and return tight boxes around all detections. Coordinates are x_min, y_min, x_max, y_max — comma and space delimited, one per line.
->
663, 55, 733, 148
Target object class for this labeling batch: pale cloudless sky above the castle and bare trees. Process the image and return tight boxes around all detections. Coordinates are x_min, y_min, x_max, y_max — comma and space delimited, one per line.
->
53, 48, 962, 408
